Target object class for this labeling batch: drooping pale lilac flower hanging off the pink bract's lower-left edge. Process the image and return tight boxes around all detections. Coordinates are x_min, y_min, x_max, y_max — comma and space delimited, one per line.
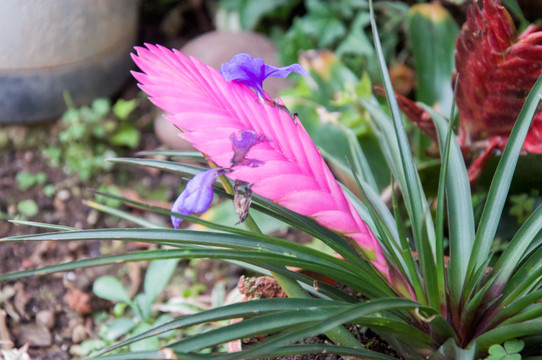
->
171, 168, 225, 229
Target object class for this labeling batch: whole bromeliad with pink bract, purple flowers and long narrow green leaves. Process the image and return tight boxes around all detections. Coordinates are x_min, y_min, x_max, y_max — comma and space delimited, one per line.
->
0, 1, 542, 359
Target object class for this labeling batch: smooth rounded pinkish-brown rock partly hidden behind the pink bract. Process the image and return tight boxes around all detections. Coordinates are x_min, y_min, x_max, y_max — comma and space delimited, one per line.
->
154, 31, 296, 150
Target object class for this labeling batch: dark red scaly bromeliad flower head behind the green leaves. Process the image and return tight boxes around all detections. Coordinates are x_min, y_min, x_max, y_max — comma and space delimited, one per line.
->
399, 0, 542, 181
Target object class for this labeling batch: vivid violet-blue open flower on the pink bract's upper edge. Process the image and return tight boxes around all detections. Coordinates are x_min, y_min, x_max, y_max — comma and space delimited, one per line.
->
220, 53, 309, 99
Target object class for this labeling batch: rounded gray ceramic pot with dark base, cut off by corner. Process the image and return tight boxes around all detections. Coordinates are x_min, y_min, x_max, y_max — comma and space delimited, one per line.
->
0, 0, 139, 123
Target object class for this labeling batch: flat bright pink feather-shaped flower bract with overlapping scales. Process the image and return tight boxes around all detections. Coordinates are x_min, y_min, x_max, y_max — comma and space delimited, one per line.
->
132, 44, 389, 276
